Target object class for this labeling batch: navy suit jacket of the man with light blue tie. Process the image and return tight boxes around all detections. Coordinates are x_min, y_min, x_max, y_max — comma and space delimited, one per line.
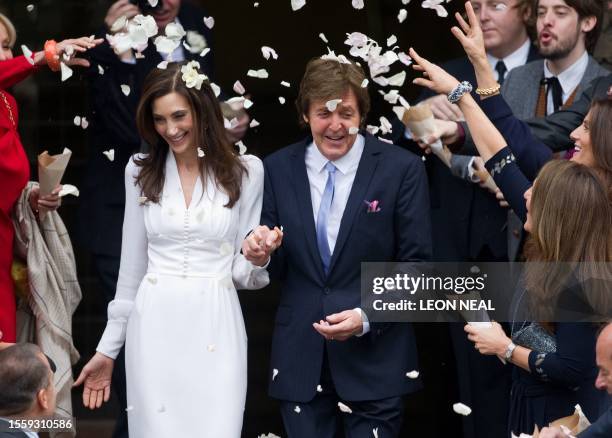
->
262, 134, 431, 402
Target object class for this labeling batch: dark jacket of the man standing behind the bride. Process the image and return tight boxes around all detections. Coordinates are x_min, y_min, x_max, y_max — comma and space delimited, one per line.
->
77, 2, 212, 257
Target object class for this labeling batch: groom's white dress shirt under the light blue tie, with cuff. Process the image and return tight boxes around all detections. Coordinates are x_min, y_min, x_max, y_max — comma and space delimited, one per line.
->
304, 134, 370, 336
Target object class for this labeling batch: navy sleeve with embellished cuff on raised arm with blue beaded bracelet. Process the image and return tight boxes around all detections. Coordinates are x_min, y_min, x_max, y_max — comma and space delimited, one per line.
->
485, 146, 531, 223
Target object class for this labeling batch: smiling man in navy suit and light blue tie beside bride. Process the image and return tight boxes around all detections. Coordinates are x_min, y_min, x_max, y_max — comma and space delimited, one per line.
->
243, 59, 431, 438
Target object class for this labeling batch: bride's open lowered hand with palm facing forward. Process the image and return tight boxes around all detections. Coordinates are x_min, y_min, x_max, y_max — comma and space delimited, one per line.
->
72, 353, 115, 409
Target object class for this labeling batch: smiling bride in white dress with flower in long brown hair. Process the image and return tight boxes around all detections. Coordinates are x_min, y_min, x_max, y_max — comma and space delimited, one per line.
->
75, 63, 282, 438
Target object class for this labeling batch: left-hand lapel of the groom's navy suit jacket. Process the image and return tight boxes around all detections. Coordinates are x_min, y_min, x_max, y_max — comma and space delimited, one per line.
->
291, 139, 325, 278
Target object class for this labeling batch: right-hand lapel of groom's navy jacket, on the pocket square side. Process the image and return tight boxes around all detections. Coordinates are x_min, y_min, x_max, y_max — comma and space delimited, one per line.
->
328, 134, 381, 273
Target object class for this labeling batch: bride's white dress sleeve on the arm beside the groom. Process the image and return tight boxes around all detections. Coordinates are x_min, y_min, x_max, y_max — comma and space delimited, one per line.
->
232, 155, 270, 289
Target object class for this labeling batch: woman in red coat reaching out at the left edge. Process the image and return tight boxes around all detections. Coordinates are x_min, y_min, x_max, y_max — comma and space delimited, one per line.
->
0, 14, 102, 342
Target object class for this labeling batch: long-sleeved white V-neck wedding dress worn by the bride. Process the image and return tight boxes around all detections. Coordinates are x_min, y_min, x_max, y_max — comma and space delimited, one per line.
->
97, 151, 269, 438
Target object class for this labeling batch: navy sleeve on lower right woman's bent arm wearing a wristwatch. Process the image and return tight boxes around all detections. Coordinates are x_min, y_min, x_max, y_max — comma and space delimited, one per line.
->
529, 322, 595, 389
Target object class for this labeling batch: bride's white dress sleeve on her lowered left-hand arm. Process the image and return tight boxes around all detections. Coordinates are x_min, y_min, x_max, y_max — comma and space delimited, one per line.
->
96, 157, 149, 359
